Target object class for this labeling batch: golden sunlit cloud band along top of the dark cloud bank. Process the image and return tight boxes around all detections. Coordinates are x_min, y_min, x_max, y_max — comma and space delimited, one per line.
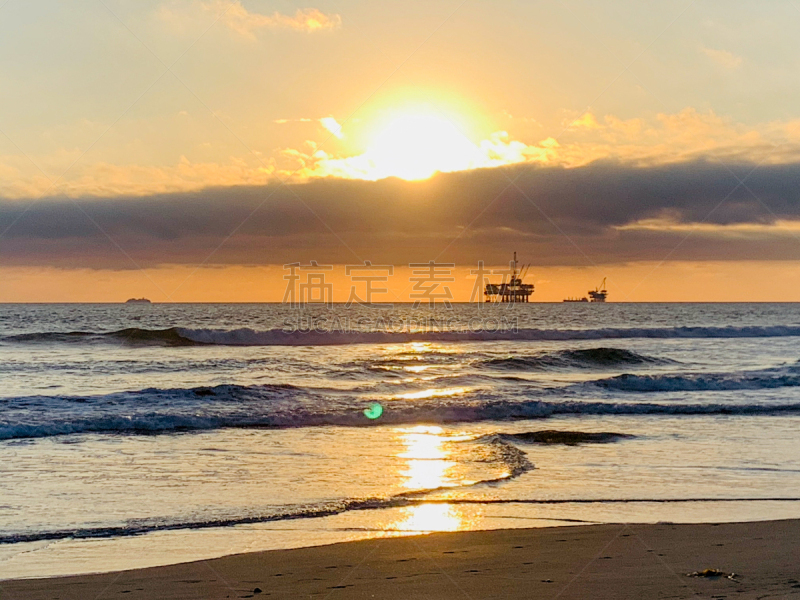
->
7, 107, 800, 198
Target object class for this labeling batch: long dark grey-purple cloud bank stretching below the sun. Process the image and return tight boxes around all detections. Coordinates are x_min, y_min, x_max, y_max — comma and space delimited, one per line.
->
0, 161, 800, 268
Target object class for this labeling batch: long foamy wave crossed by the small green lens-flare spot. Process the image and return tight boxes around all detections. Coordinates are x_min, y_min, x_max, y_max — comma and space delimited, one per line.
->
0, 380, 800, 440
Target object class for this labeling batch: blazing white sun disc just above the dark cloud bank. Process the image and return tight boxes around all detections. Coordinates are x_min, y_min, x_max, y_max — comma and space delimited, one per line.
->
365, 114, 481, 180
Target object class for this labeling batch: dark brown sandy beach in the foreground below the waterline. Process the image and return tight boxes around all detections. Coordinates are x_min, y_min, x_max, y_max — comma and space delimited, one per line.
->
0, 520, 800, 600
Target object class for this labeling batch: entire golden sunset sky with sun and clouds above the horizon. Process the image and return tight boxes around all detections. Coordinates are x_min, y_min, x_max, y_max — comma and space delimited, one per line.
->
0, 0, 800, 302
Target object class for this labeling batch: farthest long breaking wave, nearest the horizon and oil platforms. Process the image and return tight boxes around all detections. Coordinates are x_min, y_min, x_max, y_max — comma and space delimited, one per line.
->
2, 325, 800, 346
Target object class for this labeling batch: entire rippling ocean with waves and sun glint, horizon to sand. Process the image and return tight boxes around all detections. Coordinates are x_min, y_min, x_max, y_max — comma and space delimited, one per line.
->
0, 303, 800, 579
